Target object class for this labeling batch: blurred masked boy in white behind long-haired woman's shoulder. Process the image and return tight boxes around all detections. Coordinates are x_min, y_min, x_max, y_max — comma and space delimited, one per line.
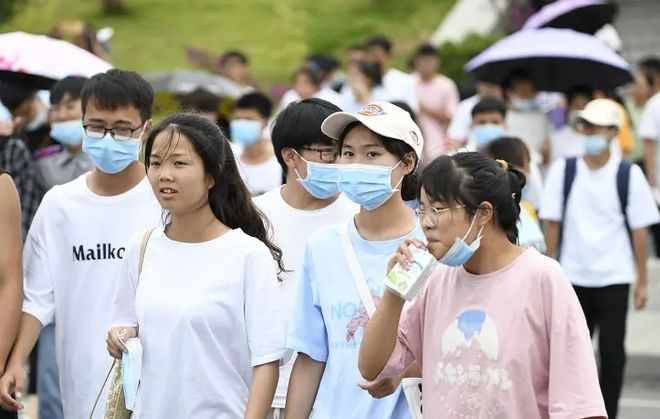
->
229, 92, 282, 196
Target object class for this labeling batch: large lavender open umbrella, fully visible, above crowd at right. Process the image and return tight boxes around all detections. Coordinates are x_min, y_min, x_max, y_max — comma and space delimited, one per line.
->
465, 28, 632, 92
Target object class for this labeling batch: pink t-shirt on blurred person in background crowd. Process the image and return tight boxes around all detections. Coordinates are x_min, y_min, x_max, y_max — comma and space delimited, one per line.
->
415, 75, 459, 161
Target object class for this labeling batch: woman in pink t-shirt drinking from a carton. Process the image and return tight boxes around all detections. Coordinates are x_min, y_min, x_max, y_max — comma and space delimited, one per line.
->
359, 153, 607, 419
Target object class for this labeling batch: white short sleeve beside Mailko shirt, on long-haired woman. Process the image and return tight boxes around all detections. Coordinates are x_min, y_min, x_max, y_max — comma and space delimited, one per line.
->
112, 232, 143, 327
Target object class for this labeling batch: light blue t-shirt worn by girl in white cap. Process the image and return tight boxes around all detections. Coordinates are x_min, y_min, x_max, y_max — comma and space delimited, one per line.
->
287, 219, 425, 419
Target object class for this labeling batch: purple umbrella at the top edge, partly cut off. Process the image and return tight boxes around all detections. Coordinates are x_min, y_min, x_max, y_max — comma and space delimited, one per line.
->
523, 0, 618, 35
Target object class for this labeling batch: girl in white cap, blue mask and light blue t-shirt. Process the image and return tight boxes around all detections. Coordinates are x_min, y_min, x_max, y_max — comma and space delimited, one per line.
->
286, 102, 423, 419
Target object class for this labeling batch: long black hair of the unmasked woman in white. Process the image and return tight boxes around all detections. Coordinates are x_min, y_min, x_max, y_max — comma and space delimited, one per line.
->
144, 114, 285, 272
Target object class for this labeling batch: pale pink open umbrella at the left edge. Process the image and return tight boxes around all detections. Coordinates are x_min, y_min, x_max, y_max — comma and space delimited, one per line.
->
0, 32, 112, 89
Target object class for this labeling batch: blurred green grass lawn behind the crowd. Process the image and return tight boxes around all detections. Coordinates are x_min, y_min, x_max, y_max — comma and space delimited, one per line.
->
5, 0, 454, 86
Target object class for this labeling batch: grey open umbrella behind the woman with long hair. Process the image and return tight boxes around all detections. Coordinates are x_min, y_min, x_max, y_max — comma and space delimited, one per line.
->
144, 70, 243, 99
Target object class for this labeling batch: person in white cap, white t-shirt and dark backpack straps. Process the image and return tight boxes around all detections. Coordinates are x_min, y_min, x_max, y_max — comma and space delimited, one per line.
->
540, 99, 660, 418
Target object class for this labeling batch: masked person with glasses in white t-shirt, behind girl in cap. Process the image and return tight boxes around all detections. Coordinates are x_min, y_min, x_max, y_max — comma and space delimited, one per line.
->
255, 99, 359, 418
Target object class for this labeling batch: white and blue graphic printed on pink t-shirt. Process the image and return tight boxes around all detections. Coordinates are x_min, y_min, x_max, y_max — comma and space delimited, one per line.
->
434, 309, 513, 418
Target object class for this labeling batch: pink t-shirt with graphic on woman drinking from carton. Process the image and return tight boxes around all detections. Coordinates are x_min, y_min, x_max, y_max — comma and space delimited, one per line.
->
379, 249, 607, 419
